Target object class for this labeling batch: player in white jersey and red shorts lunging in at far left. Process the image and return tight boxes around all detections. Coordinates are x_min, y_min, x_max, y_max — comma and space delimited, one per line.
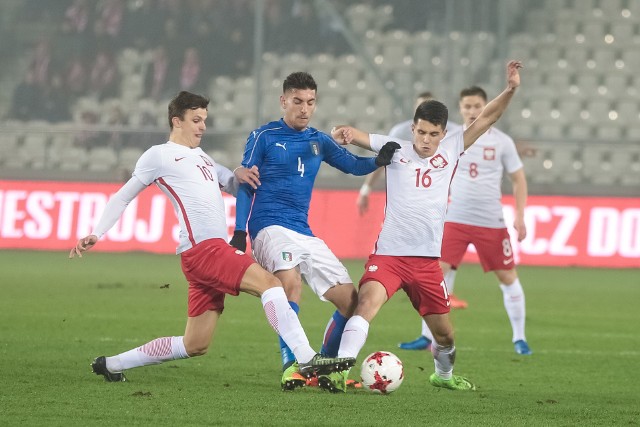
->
69, 91, 355, 381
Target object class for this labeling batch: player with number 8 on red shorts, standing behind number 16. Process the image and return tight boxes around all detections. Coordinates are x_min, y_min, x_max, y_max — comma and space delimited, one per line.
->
402, 86, 532, 355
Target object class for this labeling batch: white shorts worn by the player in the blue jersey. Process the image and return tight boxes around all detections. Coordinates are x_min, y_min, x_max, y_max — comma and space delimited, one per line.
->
251, 225, 353, 301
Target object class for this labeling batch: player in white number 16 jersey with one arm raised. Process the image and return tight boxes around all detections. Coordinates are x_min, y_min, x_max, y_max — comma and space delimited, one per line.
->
319, 61, 522, 392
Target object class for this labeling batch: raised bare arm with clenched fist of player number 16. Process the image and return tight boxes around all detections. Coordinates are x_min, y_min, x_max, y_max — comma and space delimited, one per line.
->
464, 61, 522, 150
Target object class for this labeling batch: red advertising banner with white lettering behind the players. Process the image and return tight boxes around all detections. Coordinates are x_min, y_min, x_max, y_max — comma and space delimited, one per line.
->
0, 181, 640, 268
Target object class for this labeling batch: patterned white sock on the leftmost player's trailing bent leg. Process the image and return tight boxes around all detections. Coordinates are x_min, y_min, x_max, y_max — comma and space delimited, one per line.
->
106, 337, 189, 372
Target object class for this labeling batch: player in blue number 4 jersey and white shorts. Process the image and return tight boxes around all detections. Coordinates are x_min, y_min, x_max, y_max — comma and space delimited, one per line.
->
230, 72, 399, 390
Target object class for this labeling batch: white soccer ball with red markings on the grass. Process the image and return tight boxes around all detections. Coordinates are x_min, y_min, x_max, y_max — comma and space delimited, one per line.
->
360, 351, 404, 394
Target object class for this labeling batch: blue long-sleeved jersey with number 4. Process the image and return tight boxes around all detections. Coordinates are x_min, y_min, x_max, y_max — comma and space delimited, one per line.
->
236, 119, 377, 239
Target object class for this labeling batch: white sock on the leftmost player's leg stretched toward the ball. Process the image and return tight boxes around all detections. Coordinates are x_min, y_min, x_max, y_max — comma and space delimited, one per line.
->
261, 287, 316, 363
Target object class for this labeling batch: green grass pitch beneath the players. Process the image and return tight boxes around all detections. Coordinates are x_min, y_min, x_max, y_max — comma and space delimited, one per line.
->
0, 251, 640, 426
